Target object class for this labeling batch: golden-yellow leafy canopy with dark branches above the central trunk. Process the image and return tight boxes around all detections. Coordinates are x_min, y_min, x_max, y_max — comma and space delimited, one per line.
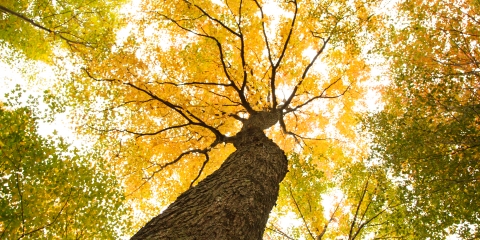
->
66, 1, 375, 232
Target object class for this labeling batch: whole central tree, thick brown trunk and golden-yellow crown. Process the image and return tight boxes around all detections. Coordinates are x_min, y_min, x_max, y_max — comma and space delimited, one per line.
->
67, 1, 375, 239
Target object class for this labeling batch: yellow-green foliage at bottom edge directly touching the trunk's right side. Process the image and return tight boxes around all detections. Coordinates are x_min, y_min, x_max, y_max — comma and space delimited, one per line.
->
264, 153, 333, 239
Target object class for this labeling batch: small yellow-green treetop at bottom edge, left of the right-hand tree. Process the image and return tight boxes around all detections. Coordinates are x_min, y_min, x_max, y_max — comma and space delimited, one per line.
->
333, 161, 410, 239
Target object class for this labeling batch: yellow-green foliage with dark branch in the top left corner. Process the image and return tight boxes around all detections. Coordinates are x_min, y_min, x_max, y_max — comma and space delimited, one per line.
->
0, 0, 122, 62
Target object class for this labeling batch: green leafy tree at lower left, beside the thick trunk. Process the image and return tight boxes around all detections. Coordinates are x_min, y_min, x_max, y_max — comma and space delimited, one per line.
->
0, 92, 127, 239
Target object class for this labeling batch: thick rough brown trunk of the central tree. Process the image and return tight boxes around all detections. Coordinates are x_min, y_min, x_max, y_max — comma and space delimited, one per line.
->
132, 128, 288, 240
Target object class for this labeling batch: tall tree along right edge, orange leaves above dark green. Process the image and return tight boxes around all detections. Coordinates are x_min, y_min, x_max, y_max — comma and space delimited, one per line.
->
366, 1, 480, 239
